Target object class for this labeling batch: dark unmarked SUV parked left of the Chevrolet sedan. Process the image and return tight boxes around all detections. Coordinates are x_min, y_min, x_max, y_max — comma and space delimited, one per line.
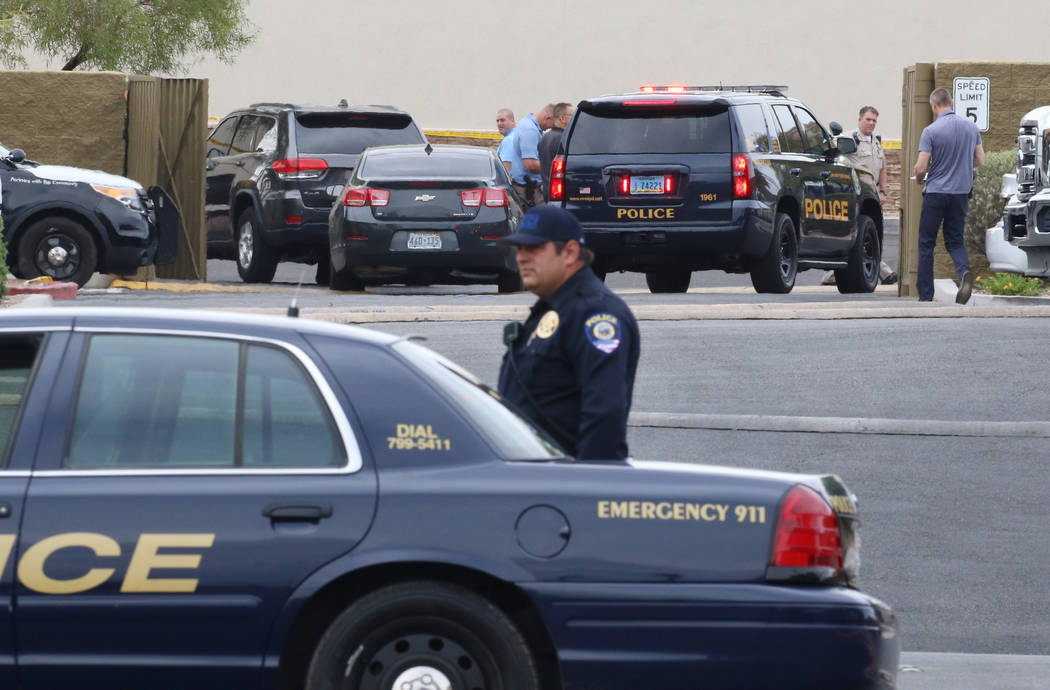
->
205, 101, 426, 285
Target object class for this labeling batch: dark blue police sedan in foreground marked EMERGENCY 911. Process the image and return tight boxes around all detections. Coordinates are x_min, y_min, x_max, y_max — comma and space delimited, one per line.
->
0, 309, 899, 690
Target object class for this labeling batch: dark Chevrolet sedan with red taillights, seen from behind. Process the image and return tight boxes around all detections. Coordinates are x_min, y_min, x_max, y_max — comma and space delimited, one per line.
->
329, 144, 523, 292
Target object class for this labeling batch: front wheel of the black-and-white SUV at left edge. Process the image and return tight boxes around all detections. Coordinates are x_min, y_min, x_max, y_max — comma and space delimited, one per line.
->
18, 215, 99, 287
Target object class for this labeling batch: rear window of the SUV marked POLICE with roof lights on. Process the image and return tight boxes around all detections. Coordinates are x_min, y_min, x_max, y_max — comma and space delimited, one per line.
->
568, 110, 732, 155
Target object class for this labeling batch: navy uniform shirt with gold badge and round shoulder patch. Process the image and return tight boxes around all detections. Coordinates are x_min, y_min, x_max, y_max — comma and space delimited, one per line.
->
499, 267, 641, 460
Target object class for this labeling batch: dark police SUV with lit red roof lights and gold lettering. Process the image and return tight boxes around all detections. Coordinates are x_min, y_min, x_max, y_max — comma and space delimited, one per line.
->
550, 86, 882, 293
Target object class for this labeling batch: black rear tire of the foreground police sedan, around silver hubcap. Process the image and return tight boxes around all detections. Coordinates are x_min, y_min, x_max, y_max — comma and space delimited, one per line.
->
306, 582, 540, 690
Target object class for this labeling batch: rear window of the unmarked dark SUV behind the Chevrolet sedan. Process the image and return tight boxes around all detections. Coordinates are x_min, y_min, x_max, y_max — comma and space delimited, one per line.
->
295, 112, 424, 153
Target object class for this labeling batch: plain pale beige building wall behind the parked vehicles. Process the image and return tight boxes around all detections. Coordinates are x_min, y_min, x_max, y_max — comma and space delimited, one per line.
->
24, 0, 1050, 140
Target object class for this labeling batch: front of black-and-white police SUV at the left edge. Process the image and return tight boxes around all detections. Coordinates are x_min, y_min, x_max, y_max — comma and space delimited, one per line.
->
0, 145, 180, 286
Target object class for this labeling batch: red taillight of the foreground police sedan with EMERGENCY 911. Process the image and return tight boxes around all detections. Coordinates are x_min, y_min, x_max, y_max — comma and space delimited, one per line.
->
770, 484, 842, 570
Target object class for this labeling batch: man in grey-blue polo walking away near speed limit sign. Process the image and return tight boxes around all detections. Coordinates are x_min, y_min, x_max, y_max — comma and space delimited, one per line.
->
915, 88, 985, 305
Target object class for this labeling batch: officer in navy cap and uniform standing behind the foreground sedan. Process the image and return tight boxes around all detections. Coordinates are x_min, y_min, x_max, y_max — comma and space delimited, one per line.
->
499, 206, 641, 460
